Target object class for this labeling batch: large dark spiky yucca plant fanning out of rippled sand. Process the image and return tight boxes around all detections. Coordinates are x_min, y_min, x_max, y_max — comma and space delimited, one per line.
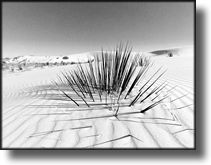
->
55, 44, 165, 116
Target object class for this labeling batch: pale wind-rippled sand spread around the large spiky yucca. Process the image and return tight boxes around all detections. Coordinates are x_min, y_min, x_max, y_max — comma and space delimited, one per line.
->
2, 48, 195, 148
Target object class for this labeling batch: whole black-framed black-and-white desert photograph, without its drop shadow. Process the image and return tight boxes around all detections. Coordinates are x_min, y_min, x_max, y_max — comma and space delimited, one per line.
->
1, 1, 196, 150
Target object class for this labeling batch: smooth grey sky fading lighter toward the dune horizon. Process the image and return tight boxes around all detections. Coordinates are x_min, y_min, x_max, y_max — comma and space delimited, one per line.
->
2, 2, 194, 57
